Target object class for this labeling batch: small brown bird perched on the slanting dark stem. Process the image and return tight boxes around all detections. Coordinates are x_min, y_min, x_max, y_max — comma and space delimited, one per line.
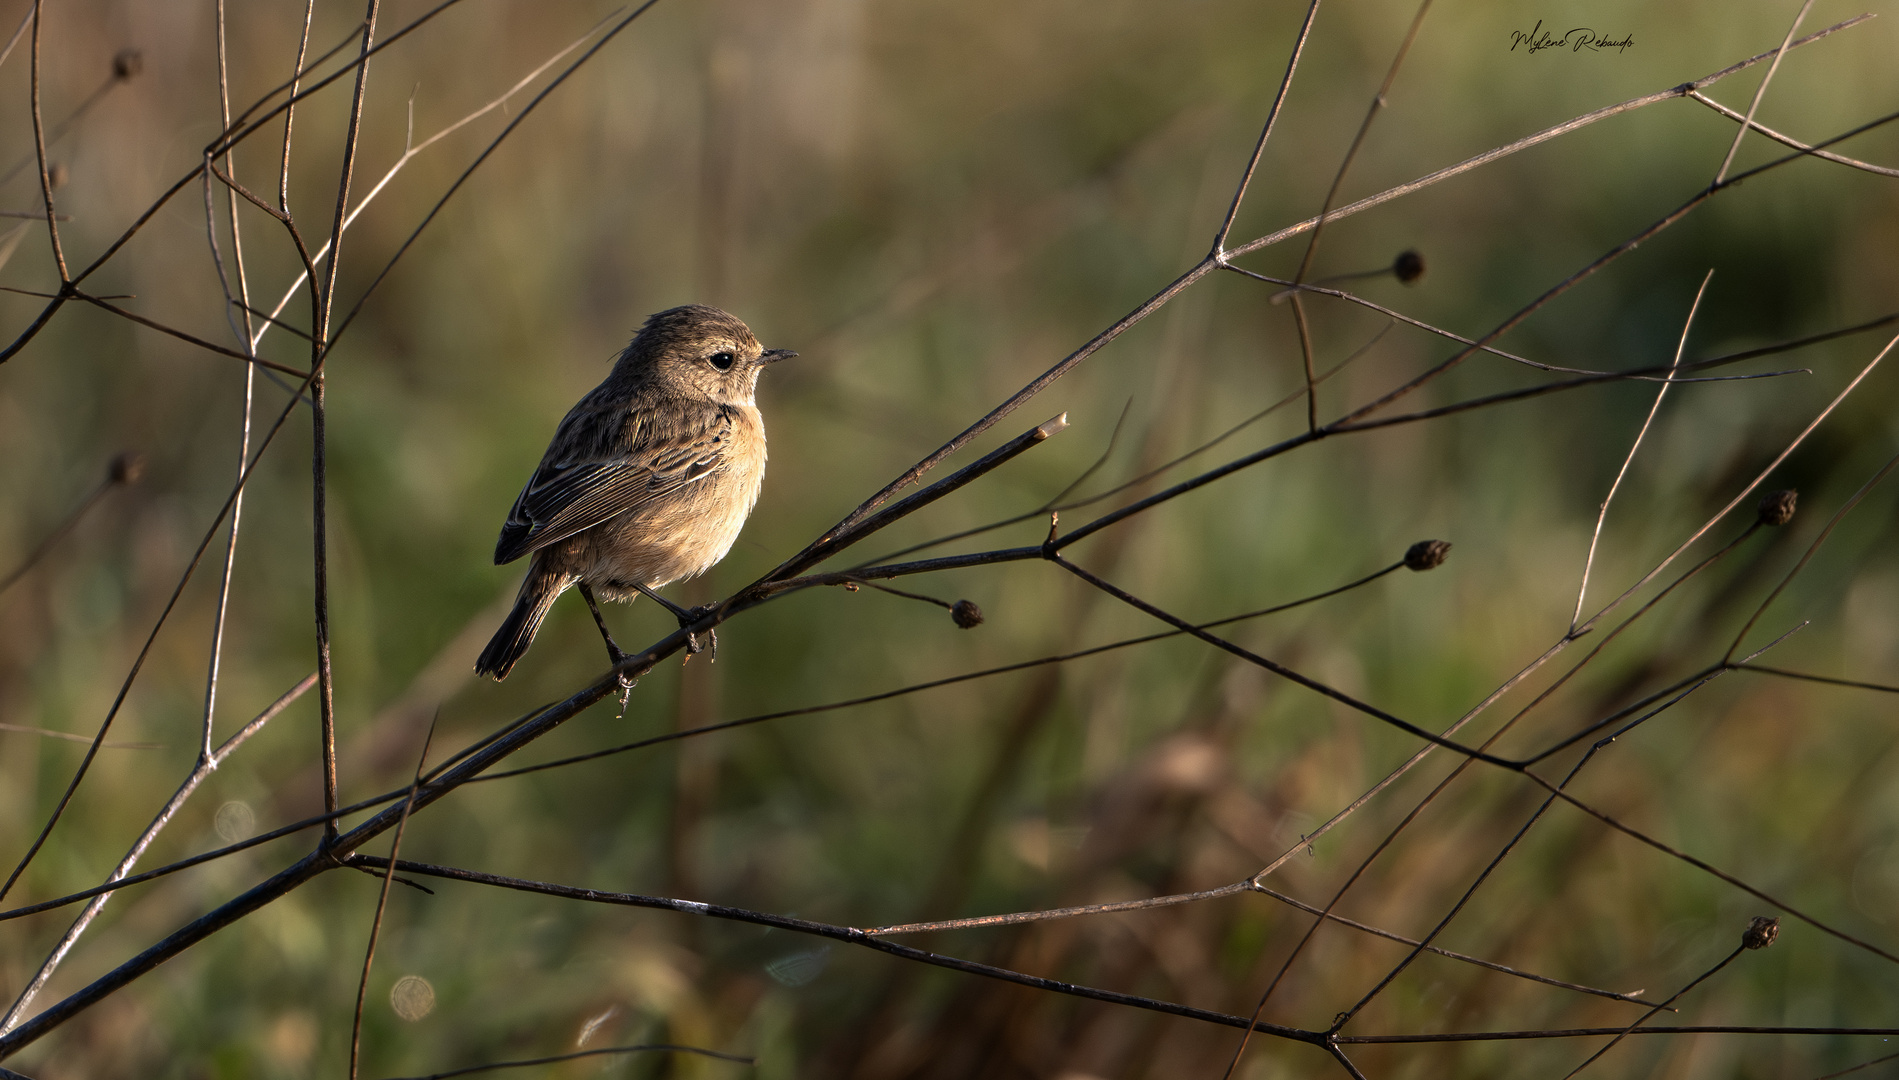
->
475, 304, 798, 680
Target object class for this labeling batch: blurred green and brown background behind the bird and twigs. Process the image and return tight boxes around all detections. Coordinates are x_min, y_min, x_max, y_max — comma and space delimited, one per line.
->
0, 0, 1899, 1080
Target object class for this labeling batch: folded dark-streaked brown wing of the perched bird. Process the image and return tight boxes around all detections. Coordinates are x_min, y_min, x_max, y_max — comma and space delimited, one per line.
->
494, 418, 731, 564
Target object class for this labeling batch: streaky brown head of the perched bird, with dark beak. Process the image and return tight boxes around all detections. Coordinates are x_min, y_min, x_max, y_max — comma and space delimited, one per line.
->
619, 304, 798, 404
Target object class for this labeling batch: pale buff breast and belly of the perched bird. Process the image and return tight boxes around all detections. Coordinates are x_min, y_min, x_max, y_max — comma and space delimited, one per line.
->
564, 408, 765, 600
